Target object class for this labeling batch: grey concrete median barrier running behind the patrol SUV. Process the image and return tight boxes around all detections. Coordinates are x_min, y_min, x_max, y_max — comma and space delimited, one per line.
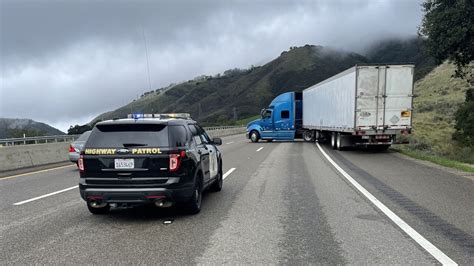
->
0, 127, 245, 172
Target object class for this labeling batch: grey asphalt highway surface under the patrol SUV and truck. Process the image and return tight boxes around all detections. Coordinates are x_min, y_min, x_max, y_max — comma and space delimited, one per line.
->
0, 135, 474, 265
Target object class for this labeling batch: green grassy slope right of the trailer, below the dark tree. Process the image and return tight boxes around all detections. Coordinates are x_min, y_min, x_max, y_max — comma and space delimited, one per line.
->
402, 63, 474, 164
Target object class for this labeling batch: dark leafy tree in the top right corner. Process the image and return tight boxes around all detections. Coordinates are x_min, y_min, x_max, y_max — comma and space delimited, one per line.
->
419, 0, 474, 79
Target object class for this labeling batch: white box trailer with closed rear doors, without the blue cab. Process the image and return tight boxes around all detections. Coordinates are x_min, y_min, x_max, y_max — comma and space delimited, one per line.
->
303, 65, 414, 149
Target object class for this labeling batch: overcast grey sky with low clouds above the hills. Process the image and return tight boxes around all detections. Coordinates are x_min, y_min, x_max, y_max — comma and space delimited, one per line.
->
0, 0, 422, 131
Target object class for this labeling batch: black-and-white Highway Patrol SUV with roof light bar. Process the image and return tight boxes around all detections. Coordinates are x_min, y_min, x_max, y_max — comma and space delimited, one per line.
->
78, 114, 223, 214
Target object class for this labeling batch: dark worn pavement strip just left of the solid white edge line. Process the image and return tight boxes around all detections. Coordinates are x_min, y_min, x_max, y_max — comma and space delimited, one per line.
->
280, 143, 347, 265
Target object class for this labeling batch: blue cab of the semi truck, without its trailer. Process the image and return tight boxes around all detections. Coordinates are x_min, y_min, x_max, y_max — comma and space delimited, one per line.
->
247, 92, 303, 142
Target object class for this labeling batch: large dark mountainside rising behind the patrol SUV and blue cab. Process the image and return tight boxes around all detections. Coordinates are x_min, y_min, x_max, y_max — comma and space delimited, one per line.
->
95, 45, 366, 125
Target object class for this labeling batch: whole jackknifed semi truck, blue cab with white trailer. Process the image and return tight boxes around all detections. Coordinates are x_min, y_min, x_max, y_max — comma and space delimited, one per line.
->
247, 64, 414, 150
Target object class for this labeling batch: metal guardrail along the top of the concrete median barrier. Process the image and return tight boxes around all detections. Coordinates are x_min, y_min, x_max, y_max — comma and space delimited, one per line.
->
0, 126, 243, 146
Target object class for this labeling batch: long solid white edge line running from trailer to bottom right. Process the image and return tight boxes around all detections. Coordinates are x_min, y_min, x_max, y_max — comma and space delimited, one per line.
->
316, 143, 457, 265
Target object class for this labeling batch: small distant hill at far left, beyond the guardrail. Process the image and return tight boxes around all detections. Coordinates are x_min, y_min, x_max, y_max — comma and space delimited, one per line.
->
0, 118, 64, 139
